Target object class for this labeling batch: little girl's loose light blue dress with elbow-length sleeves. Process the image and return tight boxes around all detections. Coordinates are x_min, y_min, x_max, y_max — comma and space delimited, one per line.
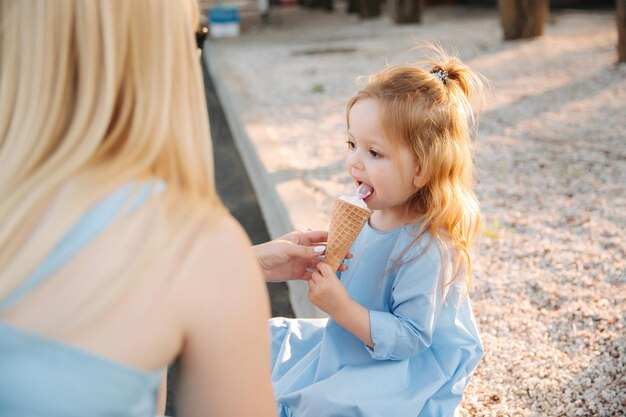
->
270, 224, 483, 417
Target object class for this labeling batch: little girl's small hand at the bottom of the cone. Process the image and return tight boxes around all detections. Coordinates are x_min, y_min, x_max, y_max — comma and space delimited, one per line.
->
309, 262, 352, 317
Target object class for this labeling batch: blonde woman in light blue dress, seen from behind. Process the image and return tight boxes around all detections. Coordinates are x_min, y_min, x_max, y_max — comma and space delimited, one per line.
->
0, 0, 326, 416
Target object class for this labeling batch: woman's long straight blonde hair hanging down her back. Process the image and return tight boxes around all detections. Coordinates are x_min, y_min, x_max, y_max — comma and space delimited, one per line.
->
0, 0, 222, 324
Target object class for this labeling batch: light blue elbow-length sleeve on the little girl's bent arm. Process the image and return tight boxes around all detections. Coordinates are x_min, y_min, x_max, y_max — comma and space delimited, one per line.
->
367, 245, 443, 360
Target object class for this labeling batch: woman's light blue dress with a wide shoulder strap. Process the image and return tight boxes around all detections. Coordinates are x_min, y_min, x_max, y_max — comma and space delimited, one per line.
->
0, 185, 164, 417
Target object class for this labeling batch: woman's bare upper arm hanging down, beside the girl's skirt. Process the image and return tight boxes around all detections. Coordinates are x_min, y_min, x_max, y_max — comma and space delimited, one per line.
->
177, 217, 276, 417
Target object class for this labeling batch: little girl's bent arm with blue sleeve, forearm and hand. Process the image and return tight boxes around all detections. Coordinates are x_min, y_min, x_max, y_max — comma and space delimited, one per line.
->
309, 245, 448, 360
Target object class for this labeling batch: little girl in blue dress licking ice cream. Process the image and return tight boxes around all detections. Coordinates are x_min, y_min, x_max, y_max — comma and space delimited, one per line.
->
270, 47, 483, 417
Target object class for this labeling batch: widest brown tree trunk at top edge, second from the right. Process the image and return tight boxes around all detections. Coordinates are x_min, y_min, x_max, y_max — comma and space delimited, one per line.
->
498, 0, 544, 40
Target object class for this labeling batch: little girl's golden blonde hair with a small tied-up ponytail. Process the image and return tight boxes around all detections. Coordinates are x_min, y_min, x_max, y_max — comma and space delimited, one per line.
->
346, 46, 483, 289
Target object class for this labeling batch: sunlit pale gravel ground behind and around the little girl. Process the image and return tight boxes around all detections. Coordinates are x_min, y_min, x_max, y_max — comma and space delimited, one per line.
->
212, 7, 626, 416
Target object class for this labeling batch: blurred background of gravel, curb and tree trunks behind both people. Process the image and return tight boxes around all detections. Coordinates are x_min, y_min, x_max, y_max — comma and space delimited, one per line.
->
169, 0, 626, 416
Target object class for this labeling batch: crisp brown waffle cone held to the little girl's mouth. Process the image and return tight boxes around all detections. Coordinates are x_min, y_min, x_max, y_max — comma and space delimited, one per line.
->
324, 199, 372, 271
